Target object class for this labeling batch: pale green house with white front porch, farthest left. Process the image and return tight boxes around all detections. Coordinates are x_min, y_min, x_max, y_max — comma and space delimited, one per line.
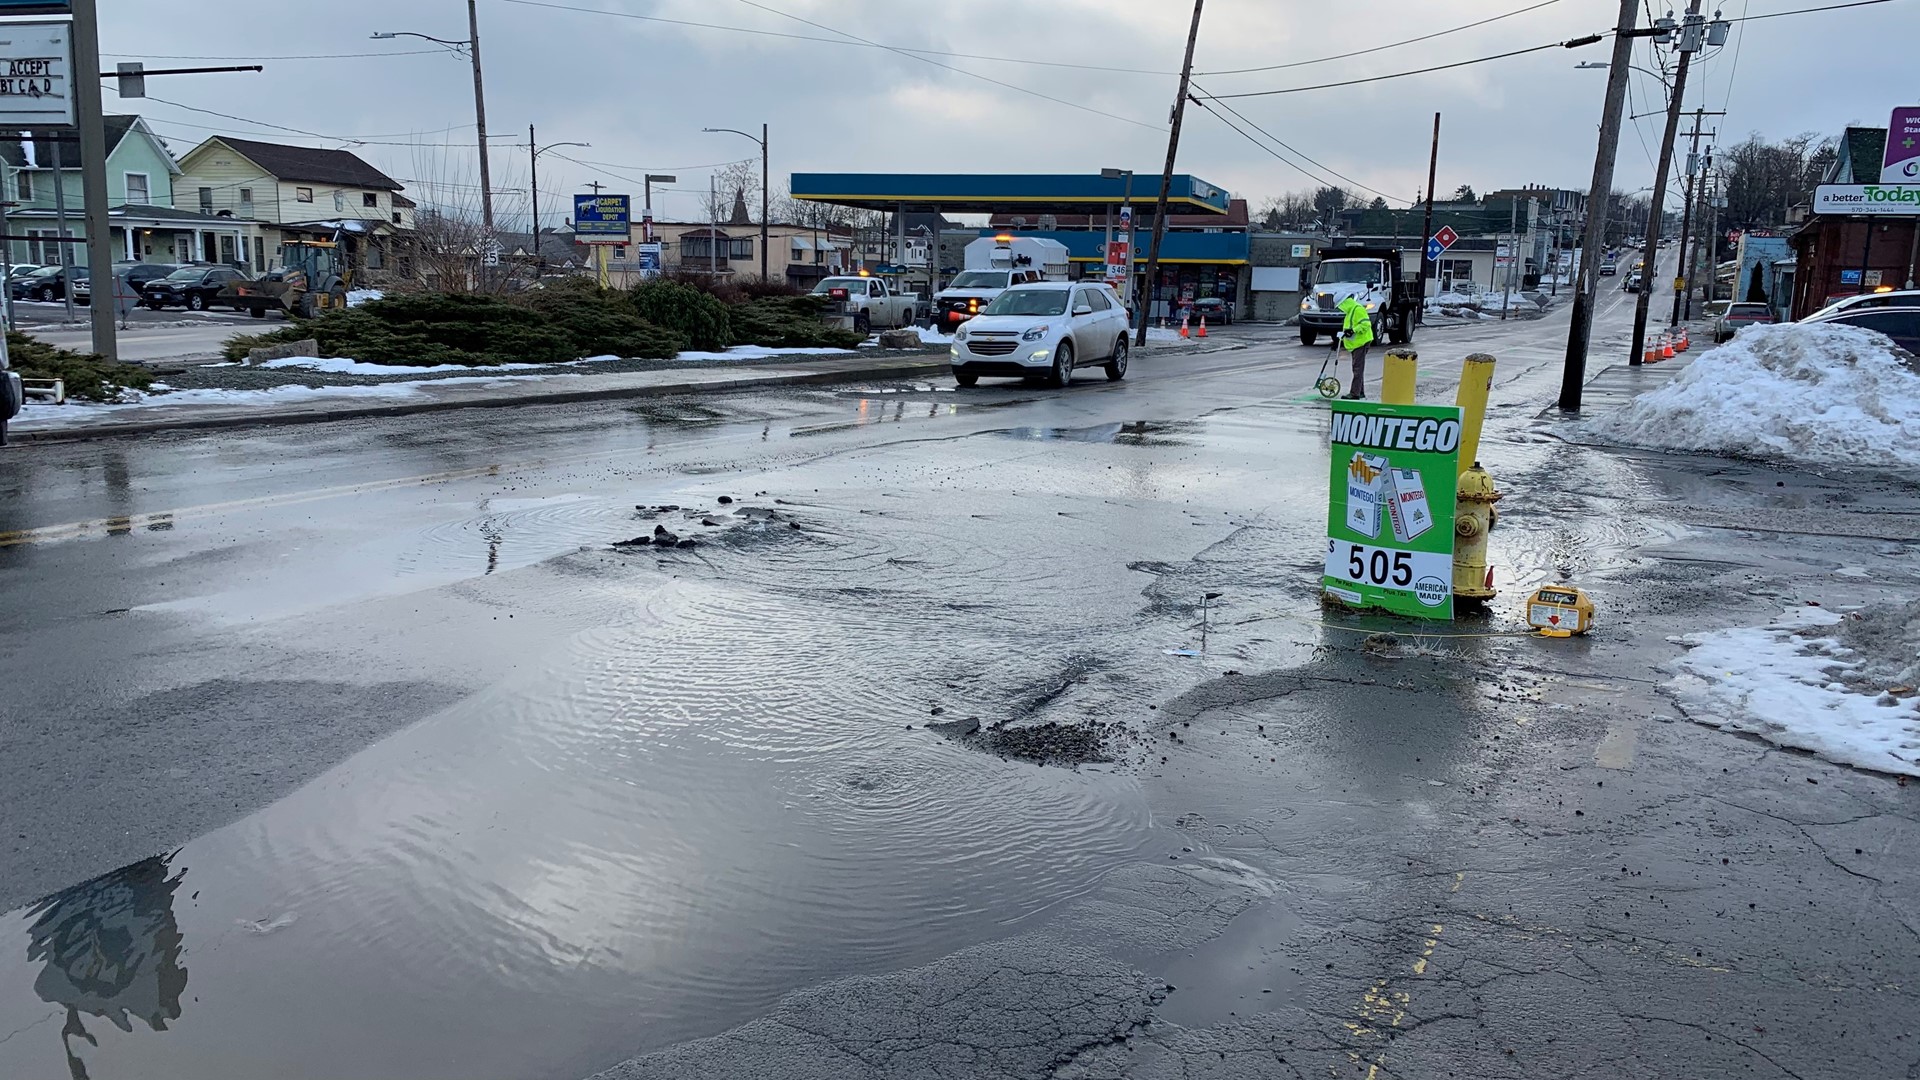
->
0, 115, 265, 269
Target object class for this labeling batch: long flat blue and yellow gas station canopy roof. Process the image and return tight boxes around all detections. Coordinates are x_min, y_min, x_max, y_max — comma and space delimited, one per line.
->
787, 173, 1227, 215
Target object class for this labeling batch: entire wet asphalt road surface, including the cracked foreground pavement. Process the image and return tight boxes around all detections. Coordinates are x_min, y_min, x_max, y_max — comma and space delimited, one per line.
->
0, 267, 1920, 1080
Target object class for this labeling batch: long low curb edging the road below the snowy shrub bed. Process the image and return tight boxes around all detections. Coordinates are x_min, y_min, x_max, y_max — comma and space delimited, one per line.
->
8, 357, 947, 444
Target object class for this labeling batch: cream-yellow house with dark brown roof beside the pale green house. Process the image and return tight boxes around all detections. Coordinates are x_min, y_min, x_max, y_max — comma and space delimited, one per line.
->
175, 135, 415, 284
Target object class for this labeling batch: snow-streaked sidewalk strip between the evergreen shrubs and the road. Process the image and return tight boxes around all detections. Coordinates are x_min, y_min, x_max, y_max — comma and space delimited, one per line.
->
8, 352, 947, 442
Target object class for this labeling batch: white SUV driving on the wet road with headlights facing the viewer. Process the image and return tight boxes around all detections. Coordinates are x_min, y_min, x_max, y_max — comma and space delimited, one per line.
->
947, 281, 1127, 386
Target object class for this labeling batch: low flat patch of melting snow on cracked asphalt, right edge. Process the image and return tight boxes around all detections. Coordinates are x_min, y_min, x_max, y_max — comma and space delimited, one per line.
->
1667, 605, 1920, 776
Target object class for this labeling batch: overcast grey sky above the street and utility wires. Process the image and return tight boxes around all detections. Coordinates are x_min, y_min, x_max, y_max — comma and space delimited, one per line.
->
100, 0, 1920, 223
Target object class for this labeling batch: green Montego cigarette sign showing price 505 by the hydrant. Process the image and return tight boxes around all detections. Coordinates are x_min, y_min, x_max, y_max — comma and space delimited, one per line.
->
1321, 402, 1459, 619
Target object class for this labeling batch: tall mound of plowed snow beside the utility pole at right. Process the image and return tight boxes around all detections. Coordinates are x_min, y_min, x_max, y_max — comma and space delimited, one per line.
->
1582, 323, 1920, 469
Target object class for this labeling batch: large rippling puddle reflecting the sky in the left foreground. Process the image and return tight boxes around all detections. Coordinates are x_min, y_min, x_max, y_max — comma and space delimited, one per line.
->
0, 568, 1148, 1080
